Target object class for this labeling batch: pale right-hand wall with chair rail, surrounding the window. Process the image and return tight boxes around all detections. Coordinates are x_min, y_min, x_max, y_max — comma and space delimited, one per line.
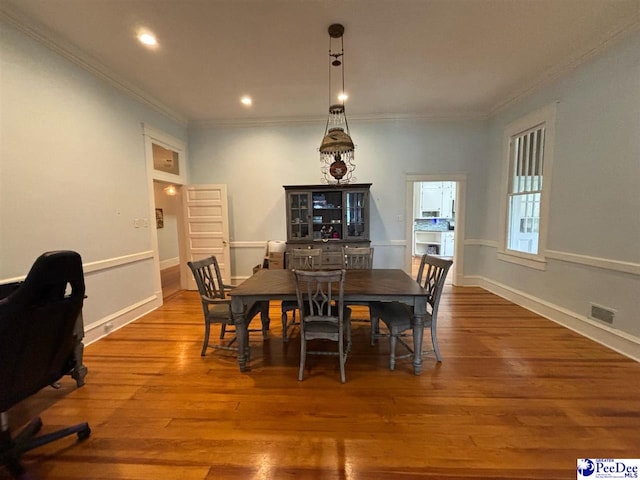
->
466, 28, 640, 358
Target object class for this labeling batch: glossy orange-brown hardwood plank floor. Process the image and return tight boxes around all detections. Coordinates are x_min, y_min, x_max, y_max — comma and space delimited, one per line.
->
6, 286, 640, 480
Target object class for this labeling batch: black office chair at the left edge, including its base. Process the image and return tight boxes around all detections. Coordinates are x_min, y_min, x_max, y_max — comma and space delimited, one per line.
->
0, 251, 91, 478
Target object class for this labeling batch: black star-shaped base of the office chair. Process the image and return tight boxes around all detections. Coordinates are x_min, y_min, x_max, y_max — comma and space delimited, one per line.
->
0, 417, 91, 479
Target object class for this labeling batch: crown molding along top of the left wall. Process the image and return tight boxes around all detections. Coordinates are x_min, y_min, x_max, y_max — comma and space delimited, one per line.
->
0, 4, 188, 127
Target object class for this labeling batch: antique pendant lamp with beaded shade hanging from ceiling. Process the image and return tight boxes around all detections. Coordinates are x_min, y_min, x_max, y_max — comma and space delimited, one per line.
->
320, 23, 356, 185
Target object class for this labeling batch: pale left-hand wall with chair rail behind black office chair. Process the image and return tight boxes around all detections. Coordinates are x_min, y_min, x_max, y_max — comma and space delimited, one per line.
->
0, 22, 186, 342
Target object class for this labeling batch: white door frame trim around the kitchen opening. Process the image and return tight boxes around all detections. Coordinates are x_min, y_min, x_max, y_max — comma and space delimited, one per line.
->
404, 173, 467, 285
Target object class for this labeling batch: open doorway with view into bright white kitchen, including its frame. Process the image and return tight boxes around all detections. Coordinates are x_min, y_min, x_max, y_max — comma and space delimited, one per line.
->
405, 174, 466, 285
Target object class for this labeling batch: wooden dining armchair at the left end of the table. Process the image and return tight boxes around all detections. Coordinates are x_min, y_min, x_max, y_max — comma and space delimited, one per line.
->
187, 256, 269, 357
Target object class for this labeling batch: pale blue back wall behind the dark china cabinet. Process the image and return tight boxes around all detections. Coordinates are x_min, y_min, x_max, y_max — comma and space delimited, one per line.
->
189, 120, 487, 277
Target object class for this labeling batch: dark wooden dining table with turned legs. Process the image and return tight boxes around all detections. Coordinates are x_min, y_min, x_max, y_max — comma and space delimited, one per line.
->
229, 268, 428, 375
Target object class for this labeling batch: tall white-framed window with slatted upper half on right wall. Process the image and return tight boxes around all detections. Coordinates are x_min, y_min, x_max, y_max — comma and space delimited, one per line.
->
500, 107, 555, 269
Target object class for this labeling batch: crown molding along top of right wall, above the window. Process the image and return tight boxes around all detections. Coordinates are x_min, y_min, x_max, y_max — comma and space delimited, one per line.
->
488, 13, 640, 117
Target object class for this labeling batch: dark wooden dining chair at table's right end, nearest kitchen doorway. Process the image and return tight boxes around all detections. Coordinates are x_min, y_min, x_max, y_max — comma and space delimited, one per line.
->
370, 254, 453, 370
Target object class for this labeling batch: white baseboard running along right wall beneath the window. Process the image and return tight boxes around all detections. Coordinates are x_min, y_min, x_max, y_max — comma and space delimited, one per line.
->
463, 276, 640, 362
